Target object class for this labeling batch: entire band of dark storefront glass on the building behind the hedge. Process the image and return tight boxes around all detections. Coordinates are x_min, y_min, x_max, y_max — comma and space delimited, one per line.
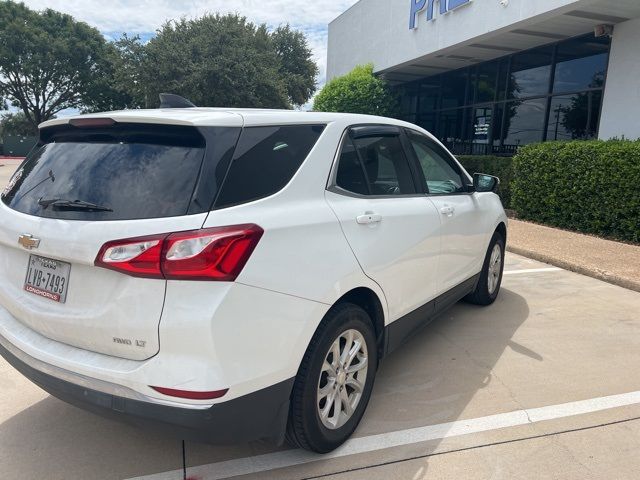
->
390, 35, 611, 154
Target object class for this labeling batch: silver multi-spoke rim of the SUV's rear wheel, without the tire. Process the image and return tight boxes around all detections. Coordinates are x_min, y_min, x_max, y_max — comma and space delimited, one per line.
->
316, 329, 369, 430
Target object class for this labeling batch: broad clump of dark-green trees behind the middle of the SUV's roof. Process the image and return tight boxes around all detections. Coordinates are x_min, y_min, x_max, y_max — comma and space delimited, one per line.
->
141, 14, 316, 108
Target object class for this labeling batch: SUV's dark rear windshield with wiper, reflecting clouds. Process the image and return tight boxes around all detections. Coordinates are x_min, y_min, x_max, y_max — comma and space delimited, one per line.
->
3, 124, 211, 221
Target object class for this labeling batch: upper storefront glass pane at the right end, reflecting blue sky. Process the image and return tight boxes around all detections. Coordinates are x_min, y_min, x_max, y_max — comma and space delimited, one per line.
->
553, 38, 609, 93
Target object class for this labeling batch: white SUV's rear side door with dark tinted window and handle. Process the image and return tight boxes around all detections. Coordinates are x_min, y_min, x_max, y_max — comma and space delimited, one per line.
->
326, 126, 440, 321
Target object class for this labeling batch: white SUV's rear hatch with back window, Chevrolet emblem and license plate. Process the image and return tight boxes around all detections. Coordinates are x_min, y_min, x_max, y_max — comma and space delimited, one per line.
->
0, 119, 240, 360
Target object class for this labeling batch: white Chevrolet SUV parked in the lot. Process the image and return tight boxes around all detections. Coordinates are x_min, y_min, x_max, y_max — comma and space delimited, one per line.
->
0, 99, 507, 452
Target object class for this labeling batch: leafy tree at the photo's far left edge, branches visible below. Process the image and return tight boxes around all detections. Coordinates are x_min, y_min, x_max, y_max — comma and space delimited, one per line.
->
0, 0, 106, 127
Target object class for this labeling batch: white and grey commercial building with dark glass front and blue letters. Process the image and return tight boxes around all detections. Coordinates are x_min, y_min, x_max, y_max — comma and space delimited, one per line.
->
327, 0, 640, 154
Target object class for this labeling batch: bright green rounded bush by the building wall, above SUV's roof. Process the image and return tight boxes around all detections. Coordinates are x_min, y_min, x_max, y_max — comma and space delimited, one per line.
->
313, 64, 397, 116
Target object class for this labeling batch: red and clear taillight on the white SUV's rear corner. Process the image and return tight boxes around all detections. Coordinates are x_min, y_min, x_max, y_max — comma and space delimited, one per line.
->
95, 224, 264, 282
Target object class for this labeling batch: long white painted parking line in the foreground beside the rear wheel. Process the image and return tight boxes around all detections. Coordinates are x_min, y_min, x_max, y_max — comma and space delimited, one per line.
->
131, 391, 640, 480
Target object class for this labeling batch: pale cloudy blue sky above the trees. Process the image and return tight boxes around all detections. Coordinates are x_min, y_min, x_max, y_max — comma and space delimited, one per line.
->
23, 0, 357, 86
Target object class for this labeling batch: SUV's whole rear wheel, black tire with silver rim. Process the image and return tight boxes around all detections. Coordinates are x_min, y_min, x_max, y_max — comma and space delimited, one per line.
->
286, 303, 378, 453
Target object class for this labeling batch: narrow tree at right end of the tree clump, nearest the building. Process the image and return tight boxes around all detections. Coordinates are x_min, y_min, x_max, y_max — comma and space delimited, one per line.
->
271, 25, 318, 105
